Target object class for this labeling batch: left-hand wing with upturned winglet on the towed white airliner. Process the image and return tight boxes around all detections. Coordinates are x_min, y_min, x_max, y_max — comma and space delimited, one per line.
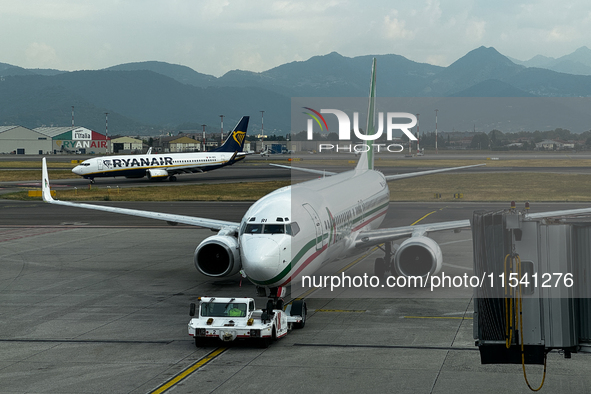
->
41, 157, 240, 231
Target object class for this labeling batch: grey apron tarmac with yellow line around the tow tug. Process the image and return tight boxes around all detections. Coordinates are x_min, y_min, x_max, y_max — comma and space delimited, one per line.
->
0, 200, 591, 393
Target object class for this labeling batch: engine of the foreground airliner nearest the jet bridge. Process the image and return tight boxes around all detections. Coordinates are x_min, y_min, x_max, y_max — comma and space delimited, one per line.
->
394, 236, 443, 276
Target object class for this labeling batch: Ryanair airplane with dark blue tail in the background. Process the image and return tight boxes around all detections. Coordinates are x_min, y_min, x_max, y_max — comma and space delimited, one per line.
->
72, 116, 249, 183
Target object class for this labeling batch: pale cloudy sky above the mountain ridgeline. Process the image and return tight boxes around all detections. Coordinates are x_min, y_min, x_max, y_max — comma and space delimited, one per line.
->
0, 0, 591, 77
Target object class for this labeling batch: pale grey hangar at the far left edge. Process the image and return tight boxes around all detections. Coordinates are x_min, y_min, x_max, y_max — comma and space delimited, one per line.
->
0, 126, 51, 155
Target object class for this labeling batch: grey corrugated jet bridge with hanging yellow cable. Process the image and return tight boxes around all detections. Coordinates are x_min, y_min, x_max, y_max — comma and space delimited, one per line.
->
472, 208, 591, 370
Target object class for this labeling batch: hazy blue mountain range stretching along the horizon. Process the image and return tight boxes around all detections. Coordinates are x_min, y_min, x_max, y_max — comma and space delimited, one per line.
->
0, 47, 591, 135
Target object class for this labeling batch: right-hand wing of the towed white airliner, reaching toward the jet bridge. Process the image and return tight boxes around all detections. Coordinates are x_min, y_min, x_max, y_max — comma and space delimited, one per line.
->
355, 220, 470, 248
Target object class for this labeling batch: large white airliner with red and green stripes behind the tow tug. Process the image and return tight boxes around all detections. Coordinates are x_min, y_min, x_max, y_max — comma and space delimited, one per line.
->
43, 60, 486, 310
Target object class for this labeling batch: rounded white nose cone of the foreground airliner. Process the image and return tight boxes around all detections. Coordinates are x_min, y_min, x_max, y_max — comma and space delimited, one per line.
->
241, 235, 281, 282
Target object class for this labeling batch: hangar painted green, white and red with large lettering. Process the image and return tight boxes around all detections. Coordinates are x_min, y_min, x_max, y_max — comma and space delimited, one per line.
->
33, 126, 109, 154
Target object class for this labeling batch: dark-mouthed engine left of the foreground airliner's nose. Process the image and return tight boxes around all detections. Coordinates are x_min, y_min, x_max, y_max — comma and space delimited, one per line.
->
193, 235, 242, 278
